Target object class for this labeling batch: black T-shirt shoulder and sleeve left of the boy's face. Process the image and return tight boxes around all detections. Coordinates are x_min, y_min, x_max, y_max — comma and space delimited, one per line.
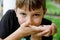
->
0, 10, 19, 38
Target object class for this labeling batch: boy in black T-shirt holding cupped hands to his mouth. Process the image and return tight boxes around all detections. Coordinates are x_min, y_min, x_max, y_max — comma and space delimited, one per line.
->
0, 0, 55, 40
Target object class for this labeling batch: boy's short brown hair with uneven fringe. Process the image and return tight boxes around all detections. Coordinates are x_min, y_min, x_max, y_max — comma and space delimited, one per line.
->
16, 0, 46, 10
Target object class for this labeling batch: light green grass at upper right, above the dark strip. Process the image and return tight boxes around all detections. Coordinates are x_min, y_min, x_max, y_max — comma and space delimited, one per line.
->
46, 1, 60, 15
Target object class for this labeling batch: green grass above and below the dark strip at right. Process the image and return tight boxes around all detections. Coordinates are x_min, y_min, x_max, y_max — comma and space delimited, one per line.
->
45, 1, 60, 40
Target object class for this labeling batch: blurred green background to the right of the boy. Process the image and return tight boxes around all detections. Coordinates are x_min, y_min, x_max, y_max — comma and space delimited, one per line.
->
45, 0, 60, 40
